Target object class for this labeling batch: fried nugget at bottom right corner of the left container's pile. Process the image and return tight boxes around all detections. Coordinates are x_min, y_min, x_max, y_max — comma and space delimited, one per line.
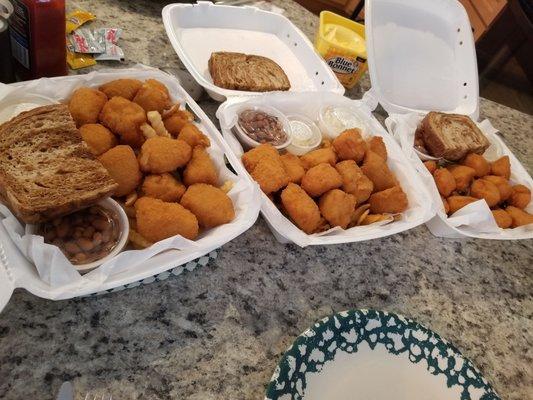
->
180, 183, 235, 228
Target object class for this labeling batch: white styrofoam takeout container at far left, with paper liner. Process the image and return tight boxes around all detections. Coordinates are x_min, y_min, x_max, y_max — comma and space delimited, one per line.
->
0, 65, 260, 310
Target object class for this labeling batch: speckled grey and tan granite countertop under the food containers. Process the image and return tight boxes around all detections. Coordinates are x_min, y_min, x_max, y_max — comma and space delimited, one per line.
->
0, 0, 533, 400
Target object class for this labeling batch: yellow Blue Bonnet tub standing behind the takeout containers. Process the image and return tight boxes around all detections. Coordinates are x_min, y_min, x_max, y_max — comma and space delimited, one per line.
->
315, 11, 367, 89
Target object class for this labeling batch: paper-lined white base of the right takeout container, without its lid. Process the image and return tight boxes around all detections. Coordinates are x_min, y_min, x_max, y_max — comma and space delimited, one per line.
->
385, 113, 533, 240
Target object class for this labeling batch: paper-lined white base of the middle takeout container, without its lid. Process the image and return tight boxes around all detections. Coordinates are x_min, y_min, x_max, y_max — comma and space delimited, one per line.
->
217, 92, 435, 247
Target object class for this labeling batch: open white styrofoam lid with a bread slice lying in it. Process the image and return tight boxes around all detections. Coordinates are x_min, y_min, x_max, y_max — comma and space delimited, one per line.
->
162, 1, 344, 101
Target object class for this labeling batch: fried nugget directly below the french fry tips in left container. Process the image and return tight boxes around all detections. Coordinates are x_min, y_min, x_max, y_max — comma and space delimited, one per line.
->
139, 136, 192, 174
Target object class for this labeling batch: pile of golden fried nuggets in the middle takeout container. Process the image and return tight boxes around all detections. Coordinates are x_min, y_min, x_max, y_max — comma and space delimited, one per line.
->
242, 129, 408, 234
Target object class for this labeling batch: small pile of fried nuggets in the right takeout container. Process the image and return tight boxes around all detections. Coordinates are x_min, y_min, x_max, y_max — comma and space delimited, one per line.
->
424, 153, 533, 229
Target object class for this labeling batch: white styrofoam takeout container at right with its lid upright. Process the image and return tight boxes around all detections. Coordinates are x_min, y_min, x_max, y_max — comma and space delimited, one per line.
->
365, 0, 533, 239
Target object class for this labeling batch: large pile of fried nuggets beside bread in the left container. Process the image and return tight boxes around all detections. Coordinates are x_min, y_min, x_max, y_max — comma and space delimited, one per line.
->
68, 79, 235, 248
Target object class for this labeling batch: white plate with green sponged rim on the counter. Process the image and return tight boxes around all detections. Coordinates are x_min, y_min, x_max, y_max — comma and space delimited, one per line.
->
265, 310, 500, 400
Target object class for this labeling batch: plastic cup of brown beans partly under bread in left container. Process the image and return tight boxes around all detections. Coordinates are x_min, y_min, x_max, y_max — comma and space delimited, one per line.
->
29, 198, 129, 272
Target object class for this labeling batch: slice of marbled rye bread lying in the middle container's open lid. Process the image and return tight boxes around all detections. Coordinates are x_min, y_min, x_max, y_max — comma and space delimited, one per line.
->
209, 51, 291, 92
